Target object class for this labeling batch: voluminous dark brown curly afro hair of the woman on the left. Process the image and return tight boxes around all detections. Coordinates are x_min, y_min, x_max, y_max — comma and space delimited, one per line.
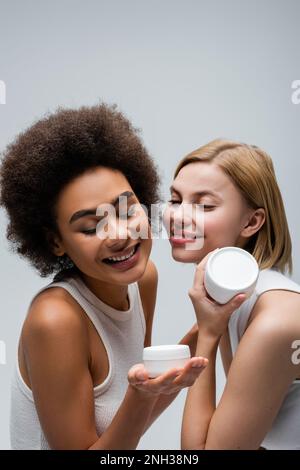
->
0, 103, 160, 280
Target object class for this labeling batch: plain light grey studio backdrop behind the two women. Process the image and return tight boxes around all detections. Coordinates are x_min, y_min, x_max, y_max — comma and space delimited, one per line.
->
0, 0, 300, 449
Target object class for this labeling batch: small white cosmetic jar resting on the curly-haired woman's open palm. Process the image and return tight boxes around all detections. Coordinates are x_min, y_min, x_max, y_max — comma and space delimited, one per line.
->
143, 344, 191, 378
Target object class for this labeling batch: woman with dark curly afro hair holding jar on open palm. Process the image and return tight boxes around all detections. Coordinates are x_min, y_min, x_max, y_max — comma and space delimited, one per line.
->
1, 104, 211, 449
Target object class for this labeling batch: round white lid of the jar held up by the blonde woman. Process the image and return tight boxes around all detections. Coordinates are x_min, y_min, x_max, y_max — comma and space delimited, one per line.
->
206, 246, 259, 290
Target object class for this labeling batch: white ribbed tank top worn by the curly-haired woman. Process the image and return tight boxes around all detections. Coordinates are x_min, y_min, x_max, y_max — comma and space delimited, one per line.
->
10, 275, 146, 450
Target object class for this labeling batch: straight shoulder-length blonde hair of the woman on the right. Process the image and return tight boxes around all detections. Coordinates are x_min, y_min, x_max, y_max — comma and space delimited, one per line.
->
174, 139, 293, 273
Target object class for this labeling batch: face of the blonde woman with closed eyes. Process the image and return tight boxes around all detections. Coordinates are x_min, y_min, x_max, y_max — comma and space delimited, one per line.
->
164, 162, 253, 263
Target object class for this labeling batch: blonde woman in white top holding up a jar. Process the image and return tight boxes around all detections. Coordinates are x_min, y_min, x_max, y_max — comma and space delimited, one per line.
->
165, 140, 300, 449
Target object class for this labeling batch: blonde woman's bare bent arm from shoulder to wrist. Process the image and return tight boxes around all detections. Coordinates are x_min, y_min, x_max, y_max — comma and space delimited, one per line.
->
182, 291, 300, 449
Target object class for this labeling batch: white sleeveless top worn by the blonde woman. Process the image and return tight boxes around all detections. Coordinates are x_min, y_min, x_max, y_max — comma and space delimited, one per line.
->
228, 269, 300, 450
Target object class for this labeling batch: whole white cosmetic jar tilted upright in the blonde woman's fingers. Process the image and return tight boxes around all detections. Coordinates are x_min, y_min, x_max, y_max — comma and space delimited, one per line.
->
204, 246, 259, 304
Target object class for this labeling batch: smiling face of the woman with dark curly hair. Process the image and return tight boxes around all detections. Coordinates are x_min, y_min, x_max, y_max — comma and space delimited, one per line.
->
54, 167, 152, 285
